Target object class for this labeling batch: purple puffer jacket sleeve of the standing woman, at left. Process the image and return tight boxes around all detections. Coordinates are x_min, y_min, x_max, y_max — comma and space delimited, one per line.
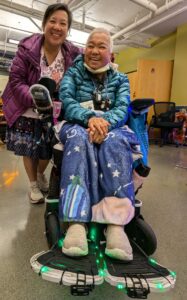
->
9, 47, 33, 108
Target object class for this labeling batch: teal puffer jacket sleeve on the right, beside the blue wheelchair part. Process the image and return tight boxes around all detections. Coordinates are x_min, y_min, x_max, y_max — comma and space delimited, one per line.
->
102, 74, 130, 130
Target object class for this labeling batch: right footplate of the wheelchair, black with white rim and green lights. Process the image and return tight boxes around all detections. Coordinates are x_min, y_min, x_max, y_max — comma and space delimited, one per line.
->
105, 242, 176, 299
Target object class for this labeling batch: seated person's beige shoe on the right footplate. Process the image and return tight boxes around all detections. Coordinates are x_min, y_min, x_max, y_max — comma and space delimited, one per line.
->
105, 225, 133, 261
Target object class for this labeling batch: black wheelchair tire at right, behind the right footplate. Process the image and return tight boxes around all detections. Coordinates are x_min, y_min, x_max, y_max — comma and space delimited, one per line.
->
127, 215, 157, 256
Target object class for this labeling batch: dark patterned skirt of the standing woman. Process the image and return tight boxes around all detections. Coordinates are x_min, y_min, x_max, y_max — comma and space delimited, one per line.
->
6, 116, 53, 159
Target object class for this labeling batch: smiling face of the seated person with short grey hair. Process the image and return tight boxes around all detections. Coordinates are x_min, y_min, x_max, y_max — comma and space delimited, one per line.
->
84, 32, 111, 70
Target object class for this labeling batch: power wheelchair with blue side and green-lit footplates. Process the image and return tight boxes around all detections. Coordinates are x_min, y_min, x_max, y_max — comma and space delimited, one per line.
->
30, 79, 176, 299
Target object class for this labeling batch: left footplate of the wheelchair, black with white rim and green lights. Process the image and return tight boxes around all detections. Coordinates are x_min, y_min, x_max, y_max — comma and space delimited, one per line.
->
30, 242, 104, 296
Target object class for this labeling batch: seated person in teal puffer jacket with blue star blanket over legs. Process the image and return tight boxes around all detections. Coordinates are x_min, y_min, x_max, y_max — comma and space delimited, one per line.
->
59, 28, 141, 260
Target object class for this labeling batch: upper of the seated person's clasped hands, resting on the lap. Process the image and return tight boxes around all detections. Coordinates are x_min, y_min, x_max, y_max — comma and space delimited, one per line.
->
88, 117, 110, 138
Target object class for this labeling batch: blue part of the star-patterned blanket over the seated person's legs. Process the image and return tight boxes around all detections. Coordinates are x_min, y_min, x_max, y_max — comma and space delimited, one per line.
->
59, 123, 141, 222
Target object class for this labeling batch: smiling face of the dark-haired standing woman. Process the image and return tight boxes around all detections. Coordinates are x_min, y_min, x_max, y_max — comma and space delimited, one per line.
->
43, 10, 68, 47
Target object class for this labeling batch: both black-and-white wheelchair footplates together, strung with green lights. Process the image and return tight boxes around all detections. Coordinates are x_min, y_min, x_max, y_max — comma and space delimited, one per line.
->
30, 241, 176, 299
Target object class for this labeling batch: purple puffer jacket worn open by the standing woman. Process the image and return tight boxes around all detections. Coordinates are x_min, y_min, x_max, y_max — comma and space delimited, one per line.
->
2, 34, 82, 127
